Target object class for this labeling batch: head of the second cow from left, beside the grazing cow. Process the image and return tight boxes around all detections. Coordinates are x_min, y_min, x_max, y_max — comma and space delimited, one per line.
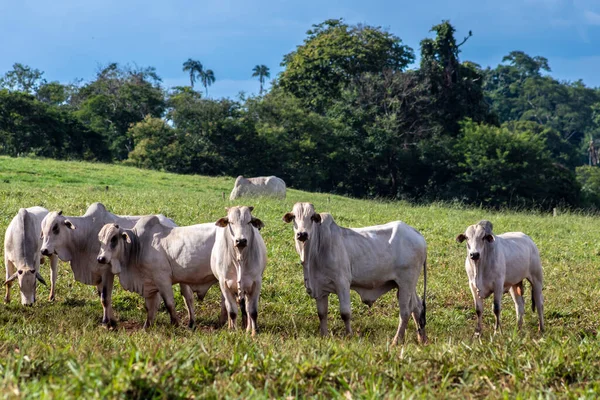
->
41, 211, 77, 261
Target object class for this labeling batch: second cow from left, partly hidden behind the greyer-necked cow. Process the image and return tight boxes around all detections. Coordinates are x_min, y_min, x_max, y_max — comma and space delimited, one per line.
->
41, 203, 175, 326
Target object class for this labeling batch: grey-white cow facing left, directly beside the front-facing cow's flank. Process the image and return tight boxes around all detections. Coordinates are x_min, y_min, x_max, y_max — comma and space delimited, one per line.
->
98, 216, 224, 328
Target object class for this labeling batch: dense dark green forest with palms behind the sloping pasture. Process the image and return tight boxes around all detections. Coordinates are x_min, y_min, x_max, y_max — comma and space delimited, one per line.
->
0, 20, 600, 209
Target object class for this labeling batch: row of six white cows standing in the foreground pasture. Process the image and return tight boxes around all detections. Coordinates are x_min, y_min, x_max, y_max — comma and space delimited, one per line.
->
4, 194, 544, 343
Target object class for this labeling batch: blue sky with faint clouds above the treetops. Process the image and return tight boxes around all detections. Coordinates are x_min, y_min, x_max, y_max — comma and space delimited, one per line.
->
0, 0, 600, 97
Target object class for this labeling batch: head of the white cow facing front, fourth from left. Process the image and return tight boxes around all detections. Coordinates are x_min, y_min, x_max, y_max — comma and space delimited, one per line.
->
215, 206, 265, 255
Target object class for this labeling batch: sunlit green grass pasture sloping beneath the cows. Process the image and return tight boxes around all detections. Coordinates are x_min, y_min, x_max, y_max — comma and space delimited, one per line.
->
0, 157, 600, 399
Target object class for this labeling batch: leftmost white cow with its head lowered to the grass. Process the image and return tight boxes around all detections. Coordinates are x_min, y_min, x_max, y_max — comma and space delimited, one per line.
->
4, 207, 58, 306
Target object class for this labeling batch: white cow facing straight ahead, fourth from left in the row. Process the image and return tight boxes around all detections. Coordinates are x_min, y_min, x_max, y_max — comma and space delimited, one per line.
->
210, 206, 267, 336
